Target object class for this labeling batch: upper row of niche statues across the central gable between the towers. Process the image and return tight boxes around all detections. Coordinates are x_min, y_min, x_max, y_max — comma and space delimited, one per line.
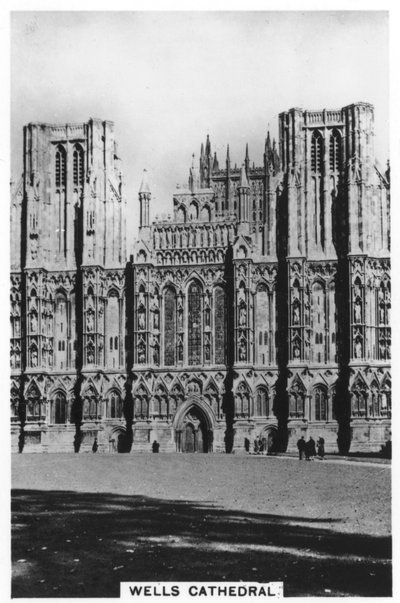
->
153, 225, 235, 249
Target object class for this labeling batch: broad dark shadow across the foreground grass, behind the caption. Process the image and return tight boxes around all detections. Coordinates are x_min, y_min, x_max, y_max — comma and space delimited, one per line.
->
12, 490, 392, 597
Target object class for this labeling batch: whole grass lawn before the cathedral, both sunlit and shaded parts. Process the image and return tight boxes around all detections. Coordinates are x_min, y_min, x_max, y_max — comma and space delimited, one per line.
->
12, 454, 391, 597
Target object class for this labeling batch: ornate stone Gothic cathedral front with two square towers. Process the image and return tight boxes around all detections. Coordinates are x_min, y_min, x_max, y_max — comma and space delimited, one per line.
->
10, 103, 391, 453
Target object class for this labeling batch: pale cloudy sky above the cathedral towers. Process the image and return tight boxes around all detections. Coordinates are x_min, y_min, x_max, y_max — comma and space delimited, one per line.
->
11, 11, 389, 252
